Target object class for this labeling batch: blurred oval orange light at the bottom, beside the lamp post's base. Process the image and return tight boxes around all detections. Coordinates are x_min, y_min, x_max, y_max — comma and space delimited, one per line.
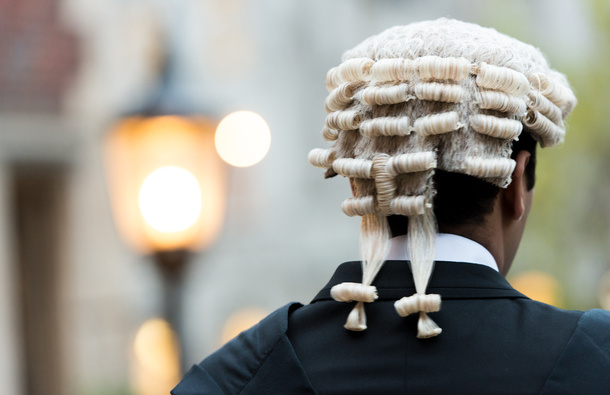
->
132, 318, 181, 395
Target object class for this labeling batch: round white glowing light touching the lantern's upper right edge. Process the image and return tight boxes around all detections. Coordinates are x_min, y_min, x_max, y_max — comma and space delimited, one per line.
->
215, 111, 271, 167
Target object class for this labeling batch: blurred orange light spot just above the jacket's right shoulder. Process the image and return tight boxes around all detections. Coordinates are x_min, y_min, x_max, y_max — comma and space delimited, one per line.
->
510, 271, 562, 307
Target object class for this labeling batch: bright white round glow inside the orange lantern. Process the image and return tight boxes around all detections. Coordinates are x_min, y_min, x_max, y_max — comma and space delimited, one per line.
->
139, 166, 201, 232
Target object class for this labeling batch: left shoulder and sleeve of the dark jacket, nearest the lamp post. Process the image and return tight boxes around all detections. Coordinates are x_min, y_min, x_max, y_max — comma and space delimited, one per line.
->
172, 303, 308, 395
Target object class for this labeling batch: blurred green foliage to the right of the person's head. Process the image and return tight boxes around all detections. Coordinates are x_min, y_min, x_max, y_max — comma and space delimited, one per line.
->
508, 0, 610, 309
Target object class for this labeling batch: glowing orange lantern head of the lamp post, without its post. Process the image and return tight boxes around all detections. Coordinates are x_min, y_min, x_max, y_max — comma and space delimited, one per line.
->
105, 116, 226, 253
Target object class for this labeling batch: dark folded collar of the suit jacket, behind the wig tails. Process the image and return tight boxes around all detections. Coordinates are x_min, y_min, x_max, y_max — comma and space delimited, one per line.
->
312, 260, 528, 303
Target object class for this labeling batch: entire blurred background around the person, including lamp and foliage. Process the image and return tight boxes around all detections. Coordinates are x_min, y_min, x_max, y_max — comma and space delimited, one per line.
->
0, 0, 610, 395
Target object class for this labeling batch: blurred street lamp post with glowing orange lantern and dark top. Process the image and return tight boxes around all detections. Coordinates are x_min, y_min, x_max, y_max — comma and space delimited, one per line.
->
104, 49, 227, 372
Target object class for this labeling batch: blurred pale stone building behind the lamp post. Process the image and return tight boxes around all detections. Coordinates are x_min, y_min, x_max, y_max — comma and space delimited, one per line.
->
0, 0, 610, 395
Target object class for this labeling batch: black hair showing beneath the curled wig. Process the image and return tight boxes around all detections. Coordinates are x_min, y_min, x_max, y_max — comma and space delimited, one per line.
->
388, 133, 536, 236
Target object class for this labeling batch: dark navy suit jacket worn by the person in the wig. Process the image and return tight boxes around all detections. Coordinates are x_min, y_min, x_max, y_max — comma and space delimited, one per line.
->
172, 261, 610, 395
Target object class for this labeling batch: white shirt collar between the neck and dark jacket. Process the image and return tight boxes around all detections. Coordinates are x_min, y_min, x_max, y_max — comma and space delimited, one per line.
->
386, 233, 499, 271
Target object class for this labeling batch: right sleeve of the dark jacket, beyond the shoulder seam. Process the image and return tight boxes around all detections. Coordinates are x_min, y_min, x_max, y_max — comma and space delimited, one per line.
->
541, 309, 610, 394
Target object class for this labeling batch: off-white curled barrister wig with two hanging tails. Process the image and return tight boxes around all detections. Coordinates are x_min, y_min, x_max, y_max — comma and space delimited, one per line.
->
309, 19, 576, 338
